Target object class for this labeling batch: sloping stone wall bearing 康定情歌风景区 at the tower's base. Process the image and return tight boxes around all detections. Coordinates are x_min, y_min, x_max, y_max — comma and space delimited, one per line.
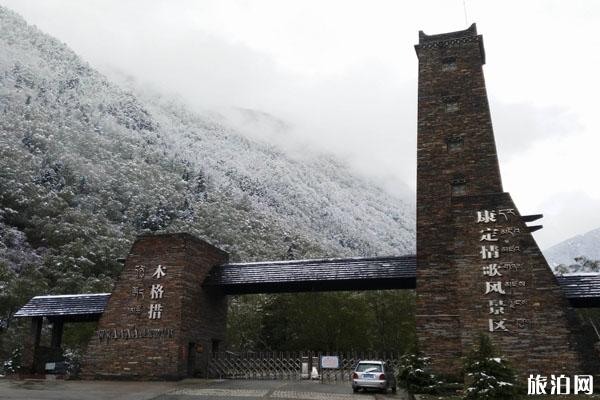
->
450, 193, 584, 376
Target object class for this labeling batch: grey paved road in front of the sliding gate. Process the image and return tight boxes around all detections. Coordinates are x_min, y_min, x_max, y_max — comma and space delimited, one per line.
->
0, 379, 406, 400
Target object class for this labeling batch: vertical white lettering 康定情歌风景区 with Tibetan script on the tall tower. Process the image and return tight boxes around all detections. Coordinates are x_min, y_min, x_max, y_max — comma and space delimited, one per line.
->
476, 208, 529, 332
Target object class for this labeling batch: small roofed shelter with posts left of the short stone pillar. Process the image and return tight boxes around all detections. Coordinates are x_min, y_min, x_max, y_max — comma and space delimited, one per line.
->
14, 293, 110, 373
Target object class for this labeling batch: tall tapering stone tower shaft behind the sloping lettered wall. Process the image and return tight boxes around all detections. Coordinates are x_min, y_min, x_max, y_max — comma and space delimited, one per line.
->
415, 25, 502, 374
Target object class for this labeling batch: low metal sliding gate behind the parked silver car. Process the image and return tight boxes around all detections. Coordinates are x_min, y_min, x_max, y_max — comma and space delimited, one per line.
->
208, 351, 401, 382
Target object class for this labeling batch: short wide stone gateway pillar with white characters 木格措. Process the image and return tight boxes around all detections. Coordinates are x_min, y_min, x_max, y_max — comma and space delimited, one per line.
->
82, 233, 228, 379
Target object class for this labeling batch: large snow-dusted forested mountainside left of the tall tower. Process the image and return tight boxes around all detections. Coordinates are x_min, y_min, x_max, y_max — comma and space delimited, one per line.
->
0, 7, 415, 292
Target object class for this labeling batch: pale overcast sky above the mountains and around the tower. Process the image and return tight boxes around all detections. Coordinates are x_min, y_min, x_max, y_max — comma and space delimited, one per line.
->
0, 0, 600, 248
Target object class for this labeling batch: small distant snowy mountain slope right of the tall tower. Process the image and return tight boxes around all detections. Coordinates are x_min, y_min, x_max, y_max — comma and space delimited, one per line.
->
544, 228, 600, 266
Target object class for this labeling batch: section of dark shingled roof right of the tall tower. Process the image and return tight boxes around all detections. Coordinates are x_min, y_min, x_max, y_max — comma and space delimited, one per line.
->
556, 273, 600, 307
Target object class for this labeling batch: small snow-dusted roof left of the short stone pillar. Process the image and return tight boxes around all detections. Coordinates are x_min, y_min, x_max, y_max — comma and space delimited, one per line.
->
15, 293, 110, 318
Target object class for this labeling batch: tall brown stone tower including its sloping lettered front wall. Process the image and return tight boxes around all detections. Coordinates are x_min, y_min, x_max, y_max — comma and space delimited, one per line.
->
415, 24, 581, 374
